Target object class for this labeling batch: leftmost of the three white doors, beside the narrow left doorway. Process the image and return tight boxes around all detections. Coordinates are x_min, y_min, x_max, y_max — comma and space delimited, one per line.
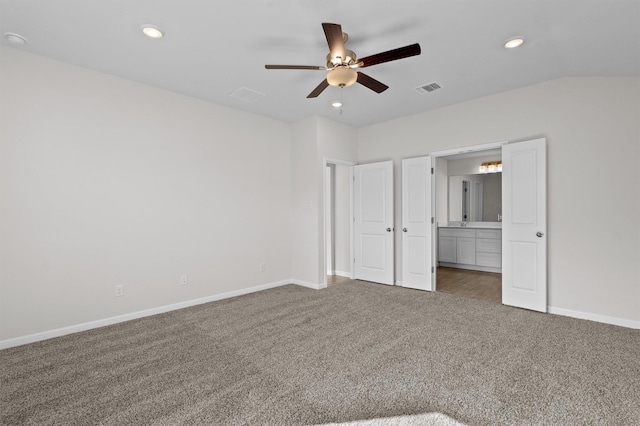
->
353, 161, 394, 285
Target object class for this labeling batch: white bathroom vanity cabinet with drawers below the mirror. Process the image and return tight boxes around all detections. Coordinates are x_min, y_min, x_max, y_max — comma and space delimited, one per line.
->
438, 227, 502, 272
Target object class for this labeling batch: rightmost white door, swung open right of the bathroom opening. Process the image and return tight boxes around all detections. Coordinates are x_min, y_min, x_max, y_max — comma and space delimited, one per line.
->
502, 139, 547, 312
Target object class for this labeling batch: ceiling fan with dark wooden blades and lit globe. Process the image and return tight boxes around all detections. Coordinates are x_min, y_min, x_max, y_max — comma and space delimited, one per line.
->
264, 23, 420, 98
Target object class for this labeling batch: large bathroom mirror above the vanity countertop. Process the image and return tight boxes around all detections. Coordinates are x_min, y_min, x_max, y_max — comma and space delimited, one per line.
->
449, 173, 502, 222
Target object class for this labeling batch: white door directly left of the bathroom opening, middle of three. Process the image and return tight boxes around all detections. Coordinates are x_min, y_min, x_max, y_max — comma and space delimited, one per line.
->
402, 157, 433, 291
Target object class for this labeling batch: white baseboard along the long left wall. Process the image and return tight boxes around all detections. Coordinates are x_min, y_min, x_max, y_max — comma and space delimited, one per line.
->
0, 280, 296, 350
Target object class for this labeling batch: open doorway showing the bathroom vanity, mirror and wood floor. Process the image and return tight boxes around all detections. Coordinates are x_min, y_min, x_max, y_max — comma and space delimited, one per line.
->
434, 147, 502, 303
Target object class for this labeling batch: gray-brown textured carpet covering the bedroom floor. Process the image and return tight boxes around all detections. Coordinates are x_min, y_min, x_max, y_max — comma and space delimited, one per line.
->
0, 281, 640, 425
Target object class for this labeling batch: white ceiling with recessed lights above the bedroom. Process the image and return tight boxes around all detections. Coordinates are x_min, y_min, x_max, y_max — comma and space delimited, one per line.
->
0, 0, 640, 127
